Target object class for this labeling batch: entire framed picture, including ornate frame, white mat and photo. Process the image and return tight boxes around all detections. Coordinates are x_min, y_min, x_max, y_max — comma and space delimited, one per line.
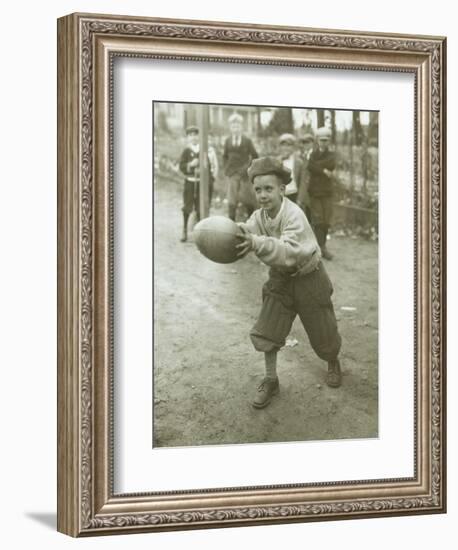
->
55, 10, 448, 546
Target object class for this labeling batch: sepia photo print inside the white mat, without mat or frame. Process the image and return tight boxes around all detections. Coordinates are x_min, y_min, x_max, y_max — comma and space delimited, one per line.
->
152, 101, 379, 448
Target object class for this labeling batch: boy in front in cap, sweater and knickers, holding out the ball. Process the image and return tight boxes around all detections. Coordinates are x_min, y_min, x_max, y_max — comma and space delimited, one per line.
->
237, 157, 341, 408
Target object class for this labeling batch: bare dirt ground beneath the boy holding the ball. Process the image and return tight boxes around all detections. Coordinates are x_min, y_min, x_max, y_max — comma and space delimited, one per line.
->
153, 177, 378, 447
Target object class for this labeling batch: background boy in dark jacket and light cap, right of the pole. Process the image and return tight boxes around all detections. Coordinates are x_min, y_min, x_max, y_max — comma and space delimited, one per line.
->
223, 113, 258, 220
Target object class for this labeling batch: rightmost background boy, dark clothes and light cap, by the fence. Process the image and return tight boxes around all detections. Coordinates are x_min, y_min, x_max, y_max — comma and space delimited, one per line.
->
308, 126, 336, 260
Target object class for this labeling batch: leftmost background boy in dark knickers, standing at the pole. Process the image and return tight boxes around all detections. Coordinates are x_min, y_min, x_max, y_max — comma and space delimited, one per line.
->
179, 126, 218, 243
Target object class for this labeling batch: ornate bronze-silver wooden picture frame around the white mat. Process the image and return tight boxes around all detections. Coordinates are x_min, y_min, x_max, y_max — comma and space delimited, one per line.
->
58, 14, 446, 536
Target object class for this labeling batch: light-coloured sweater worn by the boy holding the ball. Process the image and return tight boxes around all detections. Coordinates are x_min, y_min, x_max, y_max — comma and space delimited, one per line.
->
241, 197, 321, 275
